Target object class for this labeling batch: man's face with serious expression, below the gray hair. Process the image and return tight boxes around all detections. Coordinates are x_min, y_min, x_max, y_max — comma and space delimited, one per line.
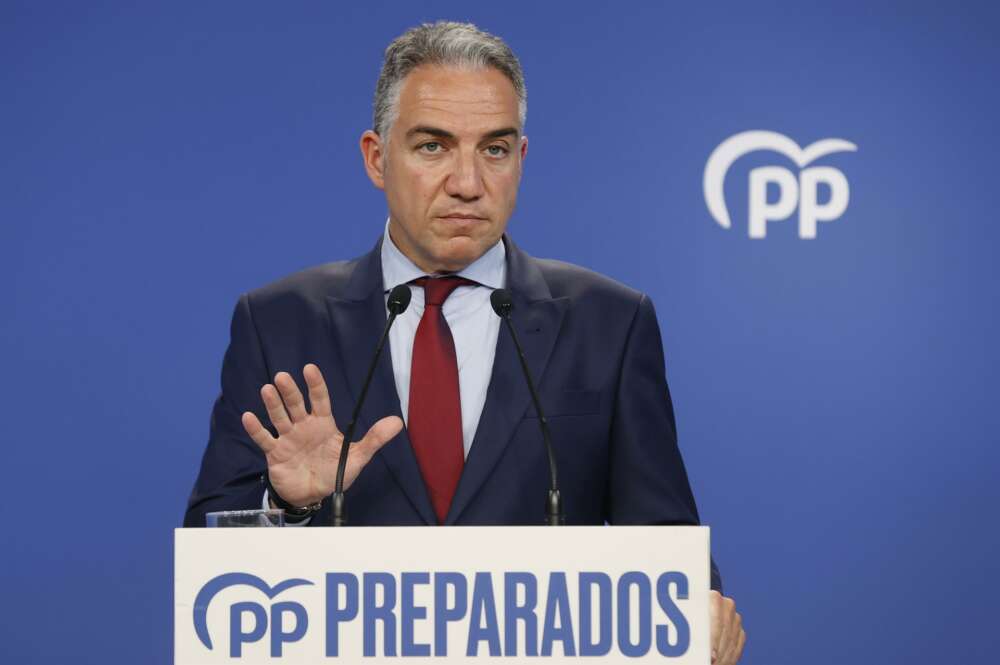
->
361, 65, 528, 273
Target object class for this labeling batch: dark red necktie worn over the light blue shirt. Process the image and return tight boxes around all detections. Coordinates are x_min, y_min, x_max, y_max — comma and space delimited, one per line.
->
406, 277, 475, 523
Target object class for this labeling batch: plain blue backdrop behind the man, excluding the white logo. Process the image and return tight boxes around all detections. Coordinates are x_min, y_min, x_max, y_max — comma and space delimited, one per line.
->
0, 0, 1000, 665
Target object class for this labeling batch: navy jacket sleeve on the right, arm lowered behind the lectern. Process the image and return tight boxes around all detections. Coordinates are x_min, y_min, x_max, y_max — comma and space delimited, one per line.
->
607, 295, 722, 590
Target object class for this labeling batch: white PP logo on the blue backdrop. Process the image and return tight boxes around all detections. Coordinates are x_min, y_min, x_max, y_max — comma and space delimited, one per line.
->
702, 131, 858, 239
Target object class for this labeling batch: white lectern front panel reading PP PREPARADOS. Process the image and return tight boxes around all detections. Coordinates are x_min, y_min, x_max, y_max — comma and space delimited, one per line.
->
174, 526, 711, 665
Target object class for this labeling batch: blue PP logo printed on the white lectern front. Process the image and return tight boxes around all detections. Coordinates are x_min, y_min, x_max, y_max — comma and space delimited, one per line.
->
194, 573, 312, 658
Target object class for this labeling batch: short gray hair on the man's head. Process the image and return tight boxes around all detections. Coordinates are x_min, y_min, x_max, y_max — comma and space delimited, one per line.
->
373, 21, 528, 140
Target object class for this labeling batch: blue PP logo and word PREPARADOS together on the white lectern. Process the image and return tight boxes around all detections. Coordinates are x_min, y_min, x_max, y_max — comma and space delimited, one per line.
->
194, 570, 692, 662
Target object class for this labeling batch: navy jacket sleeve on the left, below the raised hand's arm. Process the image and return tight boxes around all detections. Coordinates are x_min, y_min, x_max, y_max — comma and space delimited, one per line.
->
184, 294, 270, 527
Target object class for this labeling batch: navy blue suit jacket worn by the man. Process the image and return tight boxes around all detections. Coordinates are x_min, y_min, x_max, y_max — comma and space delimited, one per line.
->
184, 236, 719, 588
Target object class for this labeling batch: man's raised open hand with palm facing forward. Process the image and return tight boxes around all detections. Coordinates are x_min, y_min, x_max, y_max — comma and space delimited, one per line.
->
243, 364, 403, 506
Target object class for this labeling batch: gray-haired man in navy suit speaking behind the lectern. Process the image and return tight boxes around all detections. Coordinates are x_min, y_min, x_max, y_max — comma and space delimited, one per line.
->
185, 23, 745, 663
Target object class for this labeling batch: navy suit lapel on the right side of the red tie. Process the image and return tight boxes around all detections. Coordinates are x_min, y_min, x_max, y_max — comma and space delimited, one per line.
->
445, 236, 569, 524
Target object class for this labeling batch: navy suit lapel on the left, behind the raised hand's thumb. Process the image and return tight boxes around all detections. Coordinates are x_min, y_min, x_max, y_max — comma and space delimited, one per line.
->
327, 241, 437, 524
